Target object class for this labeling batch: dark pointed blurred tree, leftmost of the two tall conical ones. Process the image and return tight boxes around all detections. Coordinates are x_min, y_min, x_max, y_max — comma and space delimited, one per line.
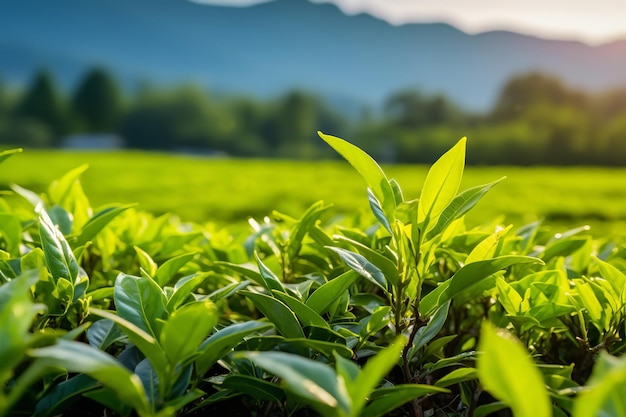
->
16, 70, 67, 140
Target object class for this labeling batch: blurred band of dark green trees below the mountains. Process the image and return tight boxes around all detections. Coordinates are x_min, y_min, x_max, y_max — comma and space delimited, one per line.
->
0, 68, 626, 165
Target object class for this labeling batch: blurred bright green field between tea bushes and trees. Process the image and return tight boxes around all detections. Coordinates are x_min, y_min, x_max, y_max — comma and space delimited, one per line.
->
0, 150, 626, 236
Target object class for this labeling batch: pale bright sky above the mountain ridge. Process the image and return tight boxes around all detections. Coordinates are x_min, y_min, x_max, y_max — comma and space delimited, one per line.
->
193, 0, 626, 45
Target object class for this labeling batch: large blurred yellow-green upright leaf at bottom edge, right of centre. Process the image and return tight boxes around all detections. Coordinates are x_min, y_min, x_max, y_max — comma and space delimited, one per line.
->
477, 322, 548, 417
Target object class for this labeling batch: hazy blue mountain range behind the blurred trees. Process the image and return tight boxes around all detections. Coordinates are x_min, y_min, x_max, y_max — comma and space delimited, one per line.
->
0, 0, 626, 111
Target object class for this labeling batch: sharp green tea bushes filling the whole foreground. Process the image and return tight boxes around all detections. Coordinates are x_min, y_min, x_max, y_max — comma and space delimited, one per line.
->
0, 133, 626, 417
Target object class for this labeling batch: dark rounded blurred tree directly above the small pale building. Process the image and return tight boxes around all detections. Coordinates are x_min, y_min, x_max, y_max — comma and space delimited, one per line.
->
72, 68, 122, 132
